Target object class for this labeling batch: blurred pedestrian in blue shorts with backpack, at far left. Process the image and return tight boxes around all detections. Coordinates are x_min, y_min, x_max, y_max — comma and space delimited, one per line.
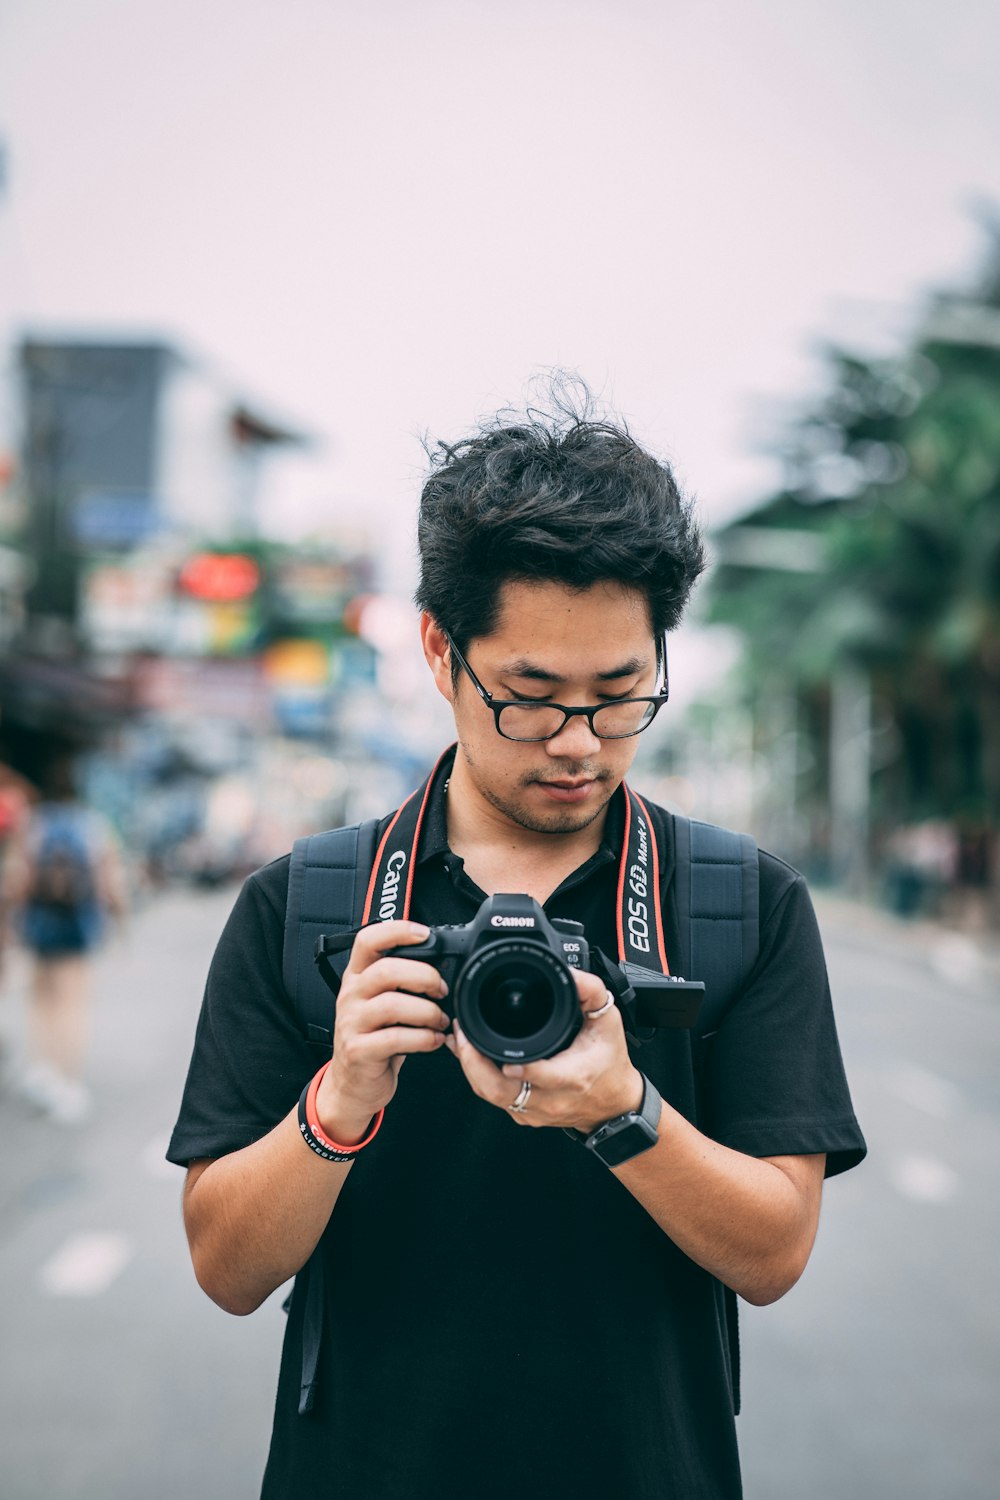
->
3, 755, 124, 1125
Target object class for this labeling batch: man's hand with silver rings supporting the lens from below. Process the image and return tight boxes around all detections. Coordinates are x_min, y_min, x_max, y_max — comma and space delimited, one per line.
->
447, 969, 643, 1134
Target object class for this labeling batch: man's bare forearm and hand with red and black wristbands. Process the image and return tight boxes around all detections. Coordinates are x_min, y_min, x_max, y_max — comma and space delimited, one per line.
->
184, 923, 450, 1314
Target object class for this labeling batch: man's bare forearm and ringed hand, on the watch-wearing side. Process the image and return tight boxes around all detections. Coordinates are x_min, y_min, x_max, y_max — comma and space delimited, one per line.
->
448, 971, 825, 1305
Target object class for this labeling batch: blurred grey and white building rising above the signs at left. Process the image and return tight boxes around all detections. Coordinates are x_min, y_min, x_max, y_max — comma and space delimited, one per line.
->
18, 339, 306, 639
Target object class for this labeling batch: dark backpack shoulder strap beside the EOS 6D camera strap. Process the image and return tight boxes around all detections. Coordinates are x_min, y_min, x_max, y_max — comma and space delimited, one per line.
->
673, 815, 760, 1035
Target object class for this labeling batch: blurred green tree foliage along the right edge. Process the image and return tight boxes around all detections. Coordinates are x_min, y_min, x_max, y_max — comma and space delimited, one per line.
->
709, 252, 1000, 824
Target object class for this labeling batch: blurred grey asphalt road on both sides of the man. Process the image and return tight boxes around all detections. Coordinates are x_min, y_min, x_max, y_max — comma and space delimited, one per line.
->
0, 887, 1000, 1500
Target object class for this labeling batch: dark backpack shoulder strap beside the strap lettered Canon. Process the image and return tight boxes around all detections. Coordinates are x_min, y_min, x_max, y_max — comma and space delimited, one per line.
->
282, 818, 379, 1047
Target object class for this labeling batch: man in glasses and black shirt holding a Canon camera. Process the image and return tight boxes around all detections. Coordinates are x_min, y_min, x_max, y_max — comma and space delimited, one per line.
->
169, 393, 865, 1500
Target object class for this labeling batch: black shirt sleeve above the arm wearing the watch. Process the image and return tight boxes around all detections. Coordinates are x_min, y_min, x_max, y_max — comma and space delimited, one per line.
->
705, 854, 867, 1178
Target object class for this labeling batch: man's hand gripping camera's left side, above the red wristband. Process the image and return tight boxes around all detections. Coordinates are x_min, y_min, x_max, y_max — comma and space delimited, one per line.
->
316, 923, 451, 1146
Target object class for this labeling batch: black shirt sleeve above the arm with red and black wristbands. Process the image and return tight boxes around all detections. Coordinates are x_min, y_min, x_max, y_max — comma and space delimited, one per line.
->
166, 860, 321, 1167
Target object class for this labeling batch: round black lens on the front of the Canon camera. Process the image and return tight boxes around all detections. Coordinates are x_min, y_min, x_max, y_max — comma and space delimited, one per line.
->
454, 938, 580, 1062
